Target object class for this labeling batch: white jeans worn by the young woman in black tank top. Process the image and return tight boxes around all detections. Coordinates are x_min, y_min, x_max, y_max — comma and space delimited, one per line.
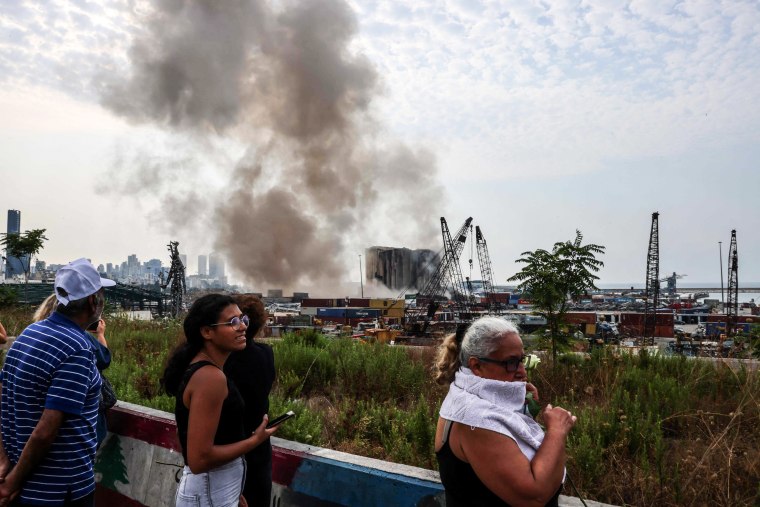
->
175, 457, 246, 507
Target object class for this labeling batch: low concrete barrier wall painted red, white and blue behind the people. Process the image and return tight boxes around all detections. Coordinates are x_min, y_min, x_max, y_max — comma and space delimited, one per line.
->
95, 402, 616, 507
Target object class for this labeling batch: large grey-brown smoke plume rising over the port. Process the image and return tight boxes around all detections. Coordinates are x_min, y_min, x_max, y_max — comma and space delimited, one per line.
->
102, 0, 443, 289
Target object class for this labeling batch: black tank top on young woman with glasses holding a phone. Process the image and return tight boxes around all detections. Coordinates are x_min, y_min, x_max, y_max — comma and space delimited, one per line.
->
174, 361, 245, 463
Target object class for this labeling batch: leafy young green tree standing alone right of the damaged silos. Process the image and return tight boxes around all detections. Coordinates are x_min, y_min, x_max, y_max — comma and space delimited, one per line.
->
508, 230, 604, 361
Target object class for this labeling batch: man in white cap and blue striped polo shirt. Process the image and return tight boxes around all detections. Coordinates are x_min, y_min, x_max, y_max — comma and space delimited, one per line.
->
0, 259, 115, 507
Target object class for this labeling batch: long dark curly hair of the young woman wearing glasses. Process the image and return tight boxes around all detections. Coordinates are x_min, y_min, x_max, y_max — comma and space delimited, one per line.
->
161, 294, 237, 396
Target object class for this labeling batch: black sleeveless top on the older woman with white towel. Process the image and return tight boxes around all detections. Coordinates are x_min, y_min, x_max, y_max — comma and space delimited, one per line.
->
435, 420, 562, 507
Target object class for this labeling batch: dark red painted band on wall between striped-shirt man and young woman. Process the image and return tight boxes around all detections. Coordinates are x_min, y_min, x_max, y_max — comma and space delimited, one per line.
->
108, 407, 182, 452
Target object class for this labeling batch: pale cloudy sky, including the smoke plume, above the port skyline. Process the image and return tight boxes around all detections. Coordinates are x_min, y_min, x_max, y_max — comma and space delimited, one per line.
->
0, 0, 760, 293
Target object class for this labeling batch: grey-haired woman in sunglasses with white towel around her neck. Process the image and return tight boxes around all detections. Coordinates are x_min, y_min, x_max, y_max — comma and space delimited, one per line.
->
435, 317, 576, 507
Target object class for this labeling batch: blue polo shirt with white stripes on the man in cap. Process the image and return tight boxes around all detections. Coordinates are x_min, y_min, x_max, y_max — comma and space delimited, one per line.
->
0, 313, 102, 505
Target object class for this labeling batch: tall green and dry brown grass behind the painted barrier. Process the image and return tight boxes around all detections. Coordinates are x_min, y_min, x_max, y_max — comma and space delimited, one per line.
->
0, 310, 760, 506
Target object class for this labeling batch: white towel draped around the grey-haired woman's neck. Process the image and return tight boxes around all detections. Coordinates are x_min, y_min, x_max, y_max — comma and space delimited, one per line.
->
441, 367, 544, 461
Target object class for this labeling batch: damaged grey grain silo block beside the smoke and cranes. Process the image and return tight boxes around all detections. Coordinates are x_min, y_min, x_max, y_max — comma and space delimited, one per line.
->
364, 246, 440, 290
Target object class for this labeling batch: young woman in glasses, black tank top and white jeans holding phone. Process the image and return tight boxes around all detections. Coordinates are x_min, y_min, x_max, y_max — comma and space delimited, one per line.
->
161, 294, 276, 507
